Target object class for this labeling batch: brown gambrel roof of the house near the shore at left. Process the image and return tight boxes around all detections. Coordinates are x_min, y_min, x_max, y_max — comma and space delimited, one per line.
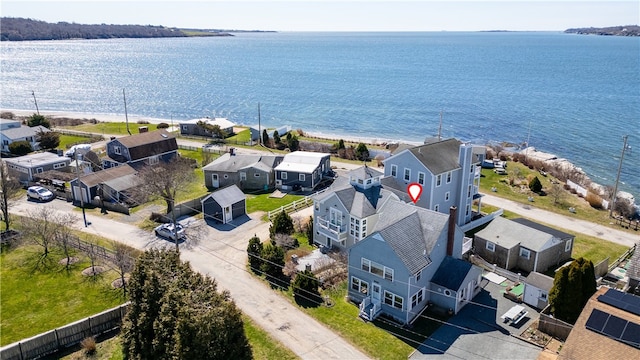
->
114, 130, 178, 161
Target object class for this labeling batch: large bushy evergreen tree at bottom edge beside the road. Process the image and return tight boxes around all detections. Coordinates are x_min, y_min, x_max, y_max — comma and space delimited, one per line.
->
122, 249, 252, 360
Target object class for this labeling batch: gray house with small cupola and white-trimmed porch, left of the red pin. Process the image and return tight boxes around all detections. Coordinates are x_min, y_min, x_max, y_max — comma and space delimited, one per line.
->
313, 166, 399, 249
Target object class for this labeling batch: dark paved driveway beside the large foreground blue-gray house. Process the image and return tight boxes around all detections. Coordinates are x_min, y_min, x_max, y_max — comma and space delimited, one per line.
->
409, 280, 542, 360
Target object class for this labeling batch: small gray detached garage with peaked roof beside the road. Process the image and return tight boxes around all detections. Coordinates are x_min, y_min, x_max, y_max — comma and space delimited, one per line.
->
200, 185, 247, 224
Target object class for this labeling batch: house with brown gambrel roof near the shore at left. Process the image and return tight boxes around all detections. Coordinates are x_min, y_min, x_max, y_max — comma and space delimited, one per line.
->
102, 130, 178, 169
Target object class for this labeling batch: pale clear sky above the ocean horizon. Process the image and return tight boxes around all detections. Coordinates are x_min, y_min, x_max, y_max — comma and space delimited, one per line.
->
0, 0, 640, 31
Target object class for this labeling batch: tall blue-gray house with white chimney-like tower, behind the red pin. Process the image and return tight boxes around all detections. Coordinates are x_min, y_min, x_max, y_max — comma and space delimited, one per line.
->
382, 139, 485, 226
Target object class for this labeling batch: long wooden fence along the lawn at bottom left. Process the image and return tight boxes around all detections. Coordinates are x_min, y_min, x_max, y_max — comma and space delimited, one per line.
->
0, 303, 129, 360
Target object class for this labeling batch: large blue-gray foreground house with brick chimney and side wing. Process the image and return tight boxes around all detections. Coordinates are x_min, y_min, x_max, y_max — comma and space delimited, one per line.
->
350, 200, 482, 324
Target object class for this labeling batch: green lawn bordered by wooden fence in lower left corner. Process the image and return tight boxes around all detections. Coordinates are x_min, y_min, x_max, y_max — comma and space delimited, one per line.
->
0, 246, 124, 345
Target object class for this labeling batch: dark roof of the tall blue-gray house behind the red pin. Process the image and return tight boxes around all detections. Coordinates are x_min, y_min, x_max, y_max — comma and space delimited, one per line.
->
408, 139, 461, 175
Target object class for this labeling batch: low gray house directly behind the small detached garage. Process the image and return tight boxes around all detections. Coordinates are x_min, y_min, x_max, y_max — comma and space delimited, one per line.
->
202, 153, 283, 190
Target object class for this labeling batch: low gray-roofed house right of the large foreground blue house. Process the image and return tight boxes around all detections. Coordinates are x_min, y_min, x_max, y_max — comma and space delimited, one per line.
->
473, 217, 574, 272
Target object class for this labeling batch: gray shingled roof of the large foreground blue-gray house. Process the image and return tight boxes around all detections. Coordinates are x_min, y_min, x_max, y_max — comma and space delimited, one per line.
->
375, 201, 449, 274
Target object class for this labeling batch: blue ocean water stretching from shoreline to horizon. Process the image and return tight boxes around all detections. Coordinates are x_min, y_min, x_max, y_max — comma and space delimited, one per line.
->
0, 32, 640, 198
